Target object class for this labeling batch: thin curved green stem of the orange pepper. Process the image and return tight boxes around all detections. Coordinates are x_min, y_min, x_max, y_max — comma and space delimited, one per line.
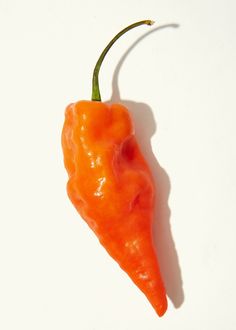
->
92, 20, 154, 101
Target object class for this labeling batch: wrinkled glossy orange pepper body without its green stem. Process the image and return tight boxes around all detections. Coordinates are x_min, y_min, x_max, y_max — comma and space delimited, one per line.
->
62, 101, 167, 316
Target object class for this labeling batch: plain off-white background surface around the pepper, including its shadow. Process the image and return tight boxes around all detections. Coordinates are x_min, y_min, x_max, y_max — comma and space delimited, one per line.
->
0, 0, 236, 330
